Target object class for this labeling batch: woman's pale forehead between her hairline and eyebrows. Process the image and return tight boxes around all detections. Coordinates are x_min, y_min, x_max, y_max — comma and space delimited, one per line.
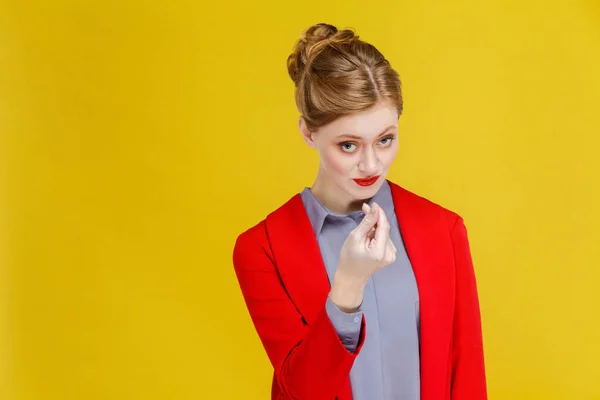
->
321, 103, 398, 139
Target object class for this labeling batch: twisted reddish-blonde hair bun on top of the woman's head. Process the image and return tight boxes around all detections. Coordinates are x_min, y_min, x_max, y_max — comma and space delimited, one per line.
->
287, 23, 358, 85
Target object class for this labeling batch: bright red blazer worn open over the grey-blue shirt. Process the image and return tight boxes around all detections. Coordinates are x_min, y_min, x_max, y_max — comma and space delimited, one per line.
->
233, 182, 487, 400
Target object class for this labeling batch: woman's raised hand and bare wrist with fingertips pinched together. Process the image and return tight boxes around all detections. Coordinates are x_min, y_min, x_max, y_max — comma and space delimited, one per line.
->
329, 203, 396, 312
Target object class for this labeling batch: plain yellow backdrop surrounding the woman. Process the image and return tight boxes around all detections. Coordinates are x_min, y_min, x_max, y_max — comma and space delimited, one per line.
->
0, 0, 600, 400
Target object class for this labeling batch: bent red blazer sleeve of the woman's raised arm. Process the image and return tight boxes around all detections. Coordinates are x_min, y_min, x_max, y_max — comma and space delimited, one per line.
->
233, 225, 365, 400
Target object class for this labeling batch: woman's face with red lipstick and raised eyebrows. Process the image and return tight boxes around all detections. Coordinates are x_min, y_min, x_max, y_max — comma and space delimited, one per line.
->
300, 102, 398, 208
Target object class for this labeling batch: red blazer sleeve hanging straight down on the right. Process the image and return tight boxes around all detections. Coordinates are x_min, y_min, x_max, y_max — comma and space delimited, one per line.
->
451, 216, 487, 400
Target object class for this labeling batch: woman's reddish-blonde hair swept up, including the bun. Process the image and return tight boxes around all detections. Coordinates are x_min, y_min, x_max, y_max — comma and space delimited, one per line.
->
287, 23, 402, 131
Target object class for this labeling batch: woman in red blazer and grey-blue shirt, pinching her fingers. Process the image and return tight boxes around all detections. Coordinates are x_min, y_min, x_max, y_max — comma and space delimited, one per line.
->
233, 24, 486, 400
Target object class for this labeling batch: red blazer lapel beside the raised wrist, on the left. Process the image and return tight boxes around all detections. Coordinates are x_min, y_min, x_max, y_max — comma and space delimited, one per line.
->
266, 194, 330, 324
